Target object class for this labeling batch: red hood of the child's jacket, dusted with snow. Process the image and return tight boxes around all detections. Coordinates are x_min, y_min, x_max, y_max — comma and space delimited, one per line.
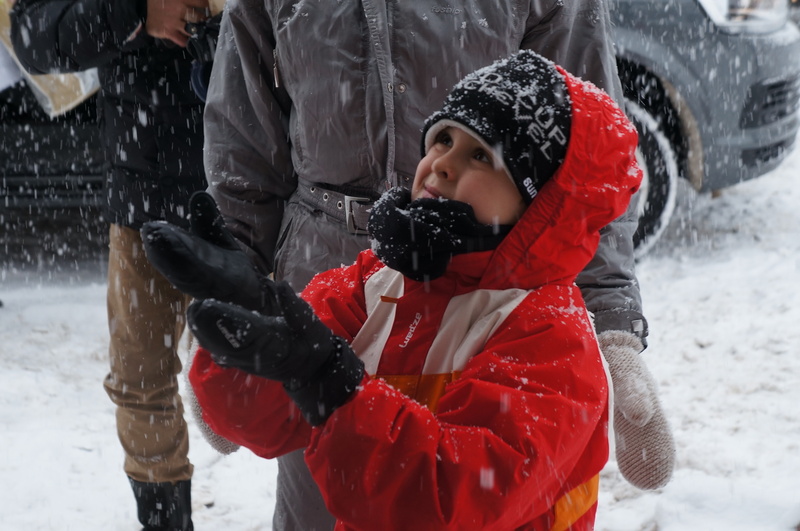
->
481, 67, 642, 289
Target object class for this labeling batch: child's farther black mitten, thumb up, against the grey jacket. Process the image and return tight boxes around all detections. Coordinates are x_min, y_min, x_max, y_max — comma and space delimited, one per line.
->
141, 192, 275, 314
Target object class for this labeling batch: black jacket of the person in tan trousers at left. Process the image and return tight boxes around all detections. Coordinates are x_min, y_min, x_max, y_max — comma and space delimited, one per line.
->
10, 0, 206, 229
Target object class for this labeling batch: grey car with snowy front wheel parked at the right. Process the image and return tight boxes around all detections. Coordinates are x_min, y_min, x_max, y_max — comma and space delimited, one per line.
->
612, 0, 800, 256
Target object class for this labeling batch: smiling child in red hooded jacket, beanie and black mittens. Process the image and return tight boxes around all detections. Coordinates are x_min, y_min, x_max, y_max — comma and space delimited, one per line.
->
147, 51, 641, 530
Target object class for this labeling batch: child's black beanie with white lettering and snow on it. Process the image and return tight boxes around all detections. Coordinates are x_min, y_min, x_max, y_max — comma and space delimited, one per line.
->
422, 50, 572, 204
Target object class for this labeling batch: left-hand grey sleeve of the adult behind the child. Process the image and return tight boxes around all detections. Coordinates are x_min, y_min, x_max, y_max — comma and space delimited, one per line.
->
204, 0, 297, 274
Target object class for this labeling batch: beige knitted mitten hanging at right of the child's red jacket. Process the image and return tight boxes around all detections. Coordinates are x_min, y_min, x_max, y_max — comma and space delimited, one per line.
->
598, 330, 675, 490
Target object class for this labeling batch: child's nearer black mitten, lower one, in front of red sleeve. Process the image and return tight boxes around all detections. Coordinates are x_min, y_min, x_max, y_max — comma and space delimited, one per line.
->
187, 283, 364, 426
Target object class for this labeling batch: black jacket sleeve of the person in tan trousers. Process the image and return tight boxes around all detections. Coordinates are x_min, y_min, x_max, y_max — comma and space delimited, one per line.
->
10, 0, 147, 74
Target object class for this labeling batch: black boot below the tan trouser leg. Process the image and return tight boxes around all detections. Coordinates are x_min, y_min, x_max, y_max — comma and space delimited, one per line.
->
128, 478, 194, 531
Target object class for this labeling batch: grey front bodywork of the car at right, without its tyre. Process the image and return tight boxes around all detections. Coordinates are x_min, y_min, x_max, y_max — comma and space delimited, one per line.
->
613, 0, 800, 190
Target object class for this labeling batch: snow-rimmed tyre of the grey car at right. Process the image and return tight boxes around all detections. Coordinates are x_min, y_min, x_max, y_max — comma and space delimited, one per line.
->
625, 99, 678, 258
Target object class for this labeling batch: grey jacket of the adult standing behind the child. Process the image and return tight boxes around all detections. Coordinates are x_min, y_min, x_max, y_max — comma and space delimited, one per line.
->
204, 0, 642, 338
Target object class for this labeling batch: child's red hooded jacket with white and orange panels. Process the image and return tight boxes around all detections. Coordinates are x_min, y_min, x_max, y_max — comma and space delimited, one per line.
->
190, 64, 641, 530
